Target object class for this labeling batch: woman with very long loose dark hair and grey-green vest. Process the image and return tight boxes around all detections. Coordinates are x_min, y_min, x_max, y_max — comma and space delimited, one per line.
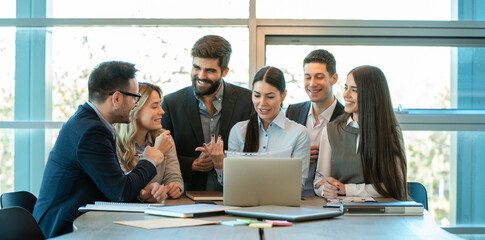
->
314, 66, 407, 200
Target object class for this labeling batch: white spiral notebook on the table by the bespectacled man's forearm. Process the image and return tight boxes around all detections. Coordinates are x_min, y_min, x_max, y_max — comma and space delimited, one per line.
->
78, 201, 165, 212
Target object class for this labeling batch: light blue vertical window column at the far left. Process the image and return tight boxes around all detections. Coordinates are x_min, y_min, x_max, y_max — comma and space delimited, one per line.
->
14, 0, 51, 195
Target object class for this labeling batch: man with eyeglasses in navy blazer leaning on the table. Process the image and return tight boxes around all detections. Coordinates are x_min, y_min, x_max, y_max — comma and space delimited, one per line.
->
33, 61, 167, 238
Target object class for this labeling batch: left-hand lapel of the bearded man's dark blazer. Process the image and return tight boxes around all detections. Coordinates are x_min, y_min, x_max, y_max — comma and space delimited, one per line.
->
182, 88, 204, 146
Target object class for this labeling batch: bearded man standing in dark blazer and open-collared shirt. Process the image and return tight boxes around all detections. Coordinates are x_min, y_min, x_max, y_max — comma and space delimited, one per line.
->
162, 35, 254, 191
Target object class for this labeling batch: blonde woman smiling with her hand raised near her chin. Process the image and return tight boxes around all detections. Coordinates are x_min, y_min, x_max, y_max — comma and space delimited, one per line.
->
115, 82, 184, 198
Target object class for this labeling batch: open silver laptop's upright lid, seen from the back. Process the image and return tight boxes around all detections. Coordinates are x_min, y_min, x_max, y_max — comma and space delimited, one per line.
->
223, 157, 301, 206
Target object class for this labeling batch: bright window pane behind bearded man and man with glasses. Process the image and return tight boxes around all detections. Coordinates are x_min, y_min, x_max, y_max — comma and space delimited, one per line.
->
52, 27, 249, 121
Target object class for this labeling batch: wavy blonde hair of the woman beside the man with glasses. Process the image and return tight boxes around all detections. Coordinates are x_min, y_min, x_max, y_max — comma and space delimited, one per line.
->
114, 82, 163, 172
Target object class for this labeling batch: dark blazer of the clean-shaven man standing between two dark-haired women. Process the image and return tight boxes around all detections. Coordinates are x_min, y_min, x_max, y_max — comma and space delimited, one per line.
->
286, 100, 345, 126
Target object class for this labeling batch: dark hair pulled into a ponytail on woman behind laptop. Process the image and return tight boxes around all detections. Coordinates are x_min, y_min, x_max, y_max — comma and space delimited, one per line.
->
243, 66, 286, 152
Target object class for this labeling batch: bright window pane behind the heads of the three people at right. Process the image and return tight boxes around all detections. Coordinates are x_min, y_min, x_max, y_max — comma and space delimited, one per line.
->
266, 45, 454, 109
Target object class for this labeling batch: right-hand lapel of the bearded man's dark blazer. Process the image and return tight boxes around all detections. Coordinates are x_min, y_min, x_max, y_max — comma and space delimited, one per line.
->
219, 82, 237, 139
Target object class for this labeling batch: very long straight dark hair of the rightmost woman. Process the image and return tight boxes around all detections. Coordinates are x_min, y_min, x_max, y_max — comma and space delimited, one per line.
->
338, 65, 407, 200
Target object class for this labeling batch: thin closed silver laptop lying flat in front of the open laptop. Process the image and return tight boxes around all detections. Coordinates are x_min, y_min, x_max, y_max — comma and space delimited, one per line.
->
225, 206, 343, 222
